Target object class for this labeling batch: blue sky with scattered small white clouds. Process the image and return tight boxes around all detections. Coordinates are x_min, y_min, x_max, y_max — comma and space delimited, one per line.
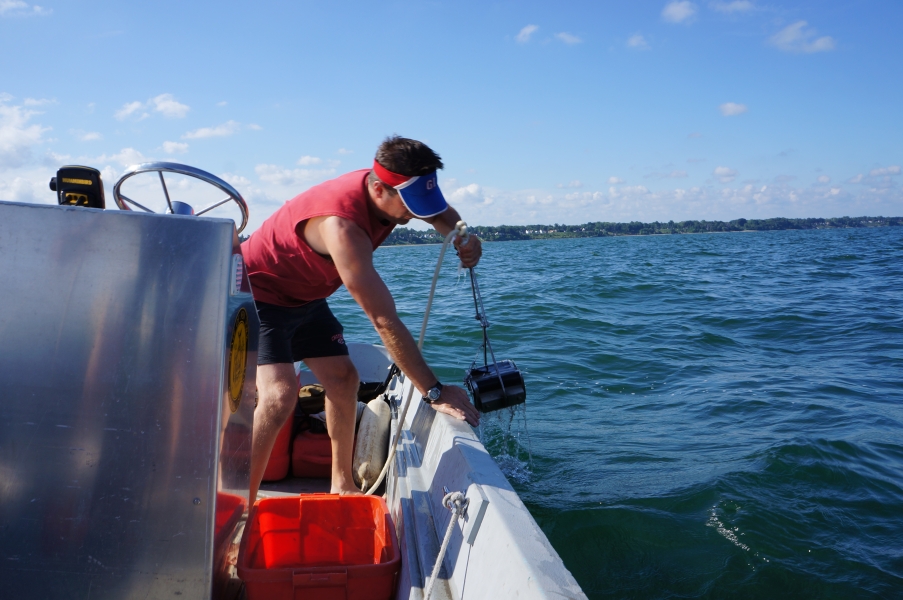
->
0, 0, 903, 233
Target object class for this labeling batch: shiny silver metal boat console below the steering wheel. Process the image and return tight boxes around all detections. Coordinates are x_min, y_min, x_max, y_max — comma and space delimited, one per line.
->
0, 202, 258, 599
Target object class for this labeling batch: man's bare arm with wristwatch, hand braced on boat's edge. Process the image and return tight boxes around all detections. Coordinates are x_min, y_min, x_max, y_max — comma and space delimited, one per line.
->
314, 217, 479, 425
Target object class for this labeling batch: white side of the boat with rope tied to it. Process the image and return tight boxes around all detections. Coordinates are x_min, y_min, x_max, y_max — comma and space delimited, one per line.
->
330, 344, 586, 600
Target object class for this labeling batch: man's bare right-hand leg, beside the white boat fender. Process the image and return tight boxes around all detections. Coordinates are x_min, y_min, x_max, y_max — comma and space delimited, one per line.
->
304, 356, 361, 494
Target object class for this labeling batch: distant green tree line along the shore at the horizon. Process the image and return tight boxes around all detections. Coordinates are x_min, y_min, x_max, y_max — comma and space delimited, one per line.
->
383, 217, 903, 246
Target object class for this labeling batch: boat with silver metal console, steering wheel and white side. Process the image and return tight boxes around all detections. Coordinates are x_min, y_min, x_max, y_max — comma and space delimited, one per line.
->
0, 163, 585, 600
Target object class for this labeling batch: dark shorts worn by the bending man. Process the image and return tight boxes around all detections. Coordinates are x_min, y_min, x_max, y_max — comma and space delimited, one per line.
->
256, 300, 348, 365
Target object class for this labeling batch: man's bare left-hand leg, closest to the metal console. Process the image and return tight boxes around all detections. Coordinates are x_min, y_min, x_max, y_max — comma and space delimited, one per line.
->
249, 363, 298, 505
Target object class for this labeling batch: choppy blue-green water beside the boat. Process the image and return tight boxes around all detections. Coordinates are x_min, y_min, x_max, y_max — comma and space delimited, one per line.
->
332, 228, 903, 599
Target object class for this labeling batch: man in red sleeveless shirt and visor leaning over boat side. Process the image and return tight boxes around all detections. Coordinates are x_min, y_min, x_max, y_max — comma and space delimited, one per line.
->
242, 136, 482, 503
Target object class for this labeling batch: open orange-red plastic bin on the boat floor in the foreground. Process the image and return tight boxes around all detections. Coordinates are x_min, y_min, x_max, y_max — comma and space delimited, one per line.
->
238, 494, 401, 600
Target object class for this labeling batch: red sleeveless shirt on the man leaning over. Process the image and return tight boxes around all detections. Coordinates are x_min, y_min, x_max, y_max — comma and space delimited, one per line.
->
241, 169, 395, 306
